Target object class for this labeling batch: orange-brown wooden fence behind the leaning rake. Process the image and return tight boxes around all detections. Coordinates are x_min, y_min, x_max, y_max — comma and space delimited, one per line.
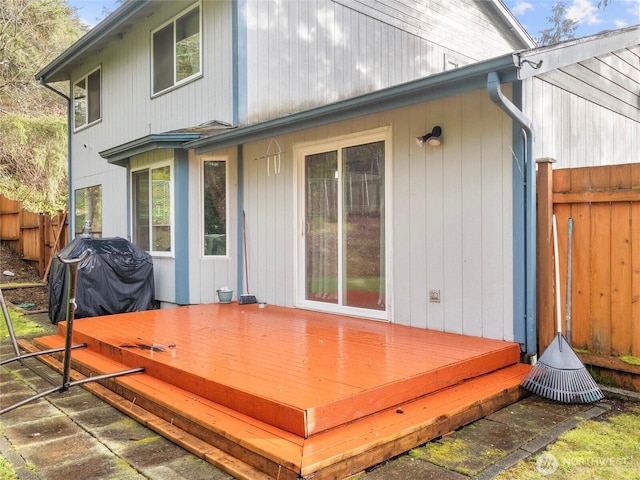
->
538, 159, 640, 390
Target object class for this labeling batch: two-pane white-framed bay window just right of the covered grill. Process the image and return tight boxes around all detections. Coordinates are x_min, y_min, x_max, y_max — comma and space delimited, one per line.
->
131, 165, 172, 253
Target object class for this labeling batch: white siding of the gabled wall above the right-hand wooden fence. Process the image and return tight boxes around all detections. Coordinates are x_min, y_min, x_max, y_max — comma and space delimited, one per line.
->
523, 44, 640, 168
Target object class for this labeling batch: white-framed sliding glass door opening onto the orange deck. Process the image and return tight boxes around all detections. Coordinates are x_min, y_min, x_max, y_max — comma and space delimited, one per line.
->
301, 133, 387, 318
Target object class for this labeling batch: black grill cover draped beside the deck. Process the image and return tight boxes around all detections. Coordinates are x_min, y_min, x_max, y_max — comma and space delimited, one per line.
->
48, 237, 156, 323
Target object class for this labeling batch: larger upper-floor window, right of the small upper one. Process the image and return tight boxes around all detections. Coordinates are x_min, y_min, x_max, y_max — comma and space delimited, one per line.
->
151, 6, 202, 94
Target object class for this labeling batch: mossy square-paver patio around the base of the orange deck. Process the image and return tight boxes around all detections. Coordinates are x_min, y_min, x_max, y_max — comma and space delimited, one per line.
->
0, 315, 620, 480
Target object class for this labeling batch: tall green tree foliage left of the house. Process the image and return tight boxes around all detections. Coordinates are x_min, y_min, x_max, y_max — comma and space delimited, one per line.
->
0, 0, 85, 211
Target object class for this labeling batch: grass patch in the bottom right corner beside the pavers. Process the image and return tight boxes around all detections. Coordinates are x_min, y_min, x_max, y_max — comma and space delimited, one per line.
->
496, 406, 640, 480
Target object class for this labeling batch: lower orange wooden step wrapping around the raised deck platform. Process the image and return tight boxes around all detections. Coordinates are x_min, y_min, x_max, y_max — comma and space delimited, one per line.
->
31, 335, 530, 475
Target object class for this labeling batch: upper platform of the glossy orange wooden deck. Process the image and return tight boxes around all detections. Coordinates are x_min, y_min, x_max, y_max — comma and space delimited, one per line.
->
51, 305, 520, 438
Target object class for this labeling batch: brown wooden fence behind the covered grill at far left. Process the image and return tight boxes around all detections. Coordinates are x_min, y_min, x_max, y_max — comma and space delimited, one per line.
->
0, 195, 69, 281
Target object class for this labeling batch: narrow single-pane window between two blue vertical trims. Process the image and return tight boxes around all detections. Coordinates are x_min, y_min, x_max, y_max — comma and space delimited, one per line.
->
202, 159, 227, 256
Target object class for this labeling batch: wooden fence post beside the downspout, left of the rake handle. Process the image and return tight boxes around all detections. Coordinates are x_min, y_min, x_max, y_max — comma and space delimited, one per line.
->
537, 158, 556, 356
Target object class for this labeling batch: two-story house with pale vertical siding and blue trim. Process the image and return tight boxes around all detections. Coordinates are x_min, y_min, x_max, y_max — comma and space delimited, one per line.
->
37, 0, 640, 362
